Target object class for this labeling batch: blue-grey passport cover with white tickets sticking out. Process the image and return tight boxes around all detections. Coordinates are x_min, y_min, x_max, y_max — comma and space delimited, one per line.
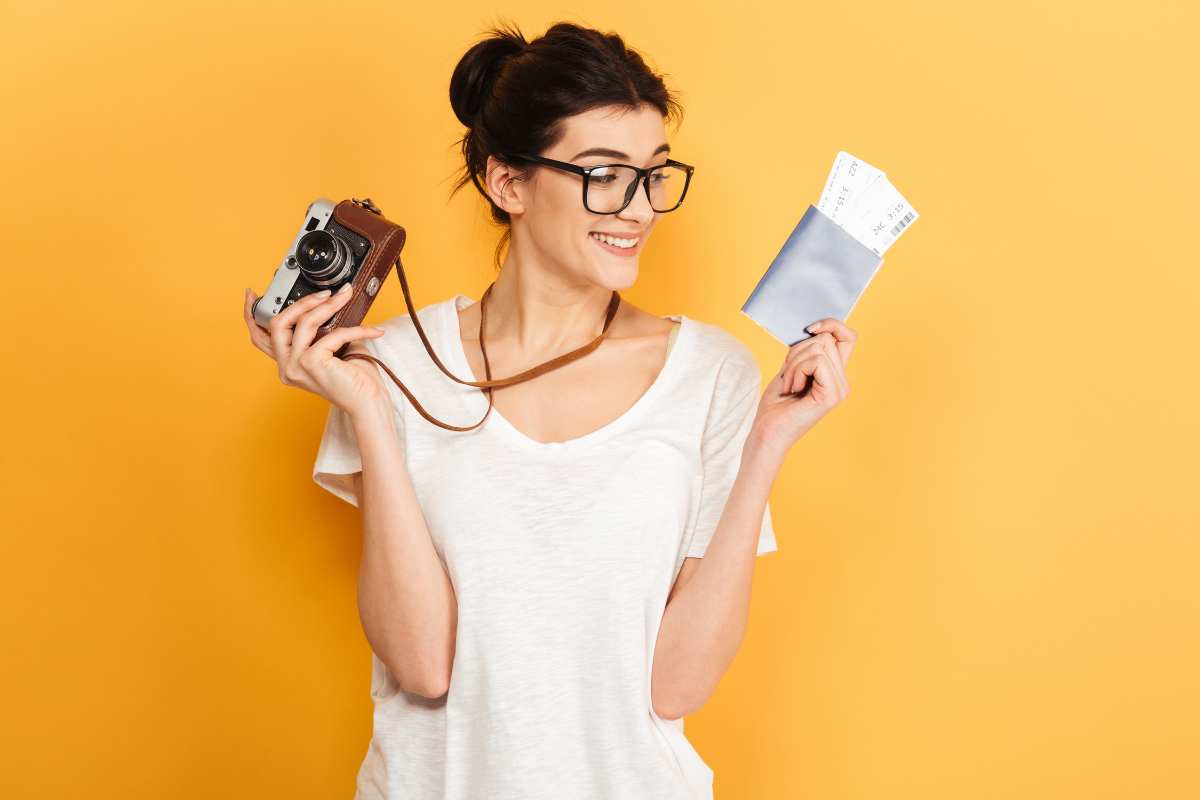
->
742, 205, 883, 347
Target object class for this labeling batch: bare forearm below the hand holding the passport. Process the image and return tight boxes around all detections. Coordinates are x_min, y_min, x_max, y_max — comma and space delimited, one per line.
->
652, 434, 781, 716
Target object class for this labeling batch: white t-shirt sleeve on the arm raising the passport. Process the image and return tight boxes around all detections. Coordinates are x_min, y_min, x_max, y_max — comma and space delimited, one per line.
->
686, 351, 779, 558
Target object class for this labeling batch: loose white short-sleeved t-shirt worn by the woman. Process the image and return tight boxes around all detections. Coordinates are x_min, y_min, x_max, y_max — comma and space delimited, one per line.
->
313, 294, 776, 800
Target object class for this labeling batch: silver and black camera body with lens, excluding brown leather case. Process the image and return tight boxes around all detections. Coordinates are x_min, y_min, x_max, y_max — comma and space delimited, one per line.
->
253, 197, 371, 327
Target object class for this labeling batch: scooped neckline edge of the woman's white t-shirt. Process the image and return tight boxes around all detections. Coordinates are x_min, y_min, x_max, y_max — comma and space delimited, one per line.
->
442, 294, 691, 453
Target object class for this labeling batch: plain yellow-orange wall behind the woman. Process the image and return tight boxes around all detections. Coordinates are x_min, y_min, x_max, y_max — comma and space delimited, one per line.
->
0, 0, 1200, 800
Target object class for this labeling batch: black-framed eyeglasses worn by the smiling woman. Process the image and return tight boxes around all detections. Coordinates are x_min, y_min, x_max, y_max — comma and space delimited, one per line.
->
504, 154, 696, 213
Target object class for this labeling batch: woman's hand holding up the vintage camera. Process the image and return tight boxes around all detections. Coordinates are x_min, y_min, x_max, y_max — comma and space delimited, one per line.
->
242, 283, 386, 415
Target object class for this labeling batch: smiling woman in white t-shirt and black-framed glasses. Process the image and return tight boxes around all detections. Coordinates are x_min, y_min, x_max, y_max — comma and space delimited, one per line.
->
238, 23, 854, 800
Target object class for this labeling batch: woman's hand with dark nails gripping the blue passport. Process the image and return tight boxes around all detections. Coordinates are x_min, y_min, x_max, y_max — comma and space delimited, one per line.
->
750, 317, 858, 459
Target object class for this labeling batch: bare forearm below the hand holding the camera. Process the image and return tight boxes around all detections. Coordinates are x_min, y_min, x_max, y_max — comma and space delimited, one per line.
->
352, 407, 457, 697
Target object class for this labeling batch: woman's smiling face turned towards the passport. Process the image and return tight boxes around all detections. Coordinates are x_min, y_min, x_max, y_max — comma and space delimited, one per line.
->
493, 106, 670, 290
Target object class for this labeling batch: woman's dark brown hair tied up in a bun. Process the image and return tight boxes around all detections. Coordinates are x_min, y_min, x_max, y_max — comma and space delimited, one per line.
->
450, 22, 683, 269
